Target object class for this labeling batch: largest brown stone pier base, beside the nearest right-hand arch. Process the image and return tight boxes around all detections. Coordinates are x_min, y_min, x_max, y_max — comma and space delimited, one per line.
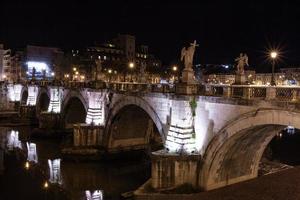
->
151, 150, 201, 190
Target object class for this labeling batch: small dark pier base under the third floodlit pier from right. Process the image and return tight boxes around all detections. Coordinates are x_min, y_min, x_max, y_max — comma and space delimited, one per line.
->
39, 112, 61, 129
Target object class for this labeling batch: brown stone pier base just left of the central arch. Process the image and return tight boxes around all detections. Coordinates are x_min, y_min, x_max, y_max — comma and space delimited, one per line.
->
73, 124, 104, 147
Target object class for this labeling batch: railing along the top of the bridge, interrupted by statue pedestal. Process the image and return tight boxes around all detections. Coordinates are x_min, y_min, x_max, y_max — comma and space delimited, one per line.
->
4, 81, 300, 102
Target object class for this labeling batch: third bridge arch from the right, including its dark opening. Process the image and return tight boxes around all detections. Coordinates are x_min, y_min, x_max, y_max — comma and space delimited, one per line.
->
61, 91, 88, 128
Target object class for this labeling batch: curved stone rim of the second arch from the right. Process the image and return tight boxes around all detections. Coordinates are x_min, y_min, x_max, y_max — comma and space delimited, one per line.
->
104, 96, 165, 148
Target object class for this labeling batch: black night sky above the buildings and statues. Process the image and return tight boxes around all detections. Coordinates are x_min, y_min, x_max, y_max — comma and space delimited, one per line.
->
0, 0, 300, 70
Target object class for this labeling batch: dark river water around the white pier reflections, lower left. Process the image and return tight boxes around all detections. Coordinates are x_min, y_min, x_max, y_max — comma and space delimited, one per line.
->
0, 126, 150, 199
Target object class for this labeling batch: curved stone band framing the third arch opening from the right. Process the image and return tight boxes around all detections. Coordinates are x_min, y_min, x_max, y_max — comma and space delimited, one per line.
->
61, 90, 88, 128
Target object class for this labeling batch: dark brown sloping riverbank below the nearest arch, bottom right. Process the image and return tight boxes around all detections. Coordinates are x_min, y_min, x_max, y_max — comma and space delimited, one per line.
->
135, 167, 300, 200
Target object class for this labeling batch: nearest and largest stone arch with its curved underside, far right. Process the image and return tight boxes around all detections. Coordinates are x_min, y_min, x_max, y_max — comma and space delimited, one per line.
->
199, 109, 300, 190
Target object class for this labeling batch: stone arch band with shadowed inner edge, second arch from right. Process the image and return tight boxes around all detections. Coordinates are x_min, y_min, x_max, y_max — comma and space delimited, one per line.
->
104, 96, 165, 148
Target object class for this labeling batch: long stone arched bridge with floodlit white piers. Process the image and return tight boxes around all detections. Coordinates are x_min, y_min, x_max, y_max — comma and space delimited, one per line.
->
7, 83, 300, 190
